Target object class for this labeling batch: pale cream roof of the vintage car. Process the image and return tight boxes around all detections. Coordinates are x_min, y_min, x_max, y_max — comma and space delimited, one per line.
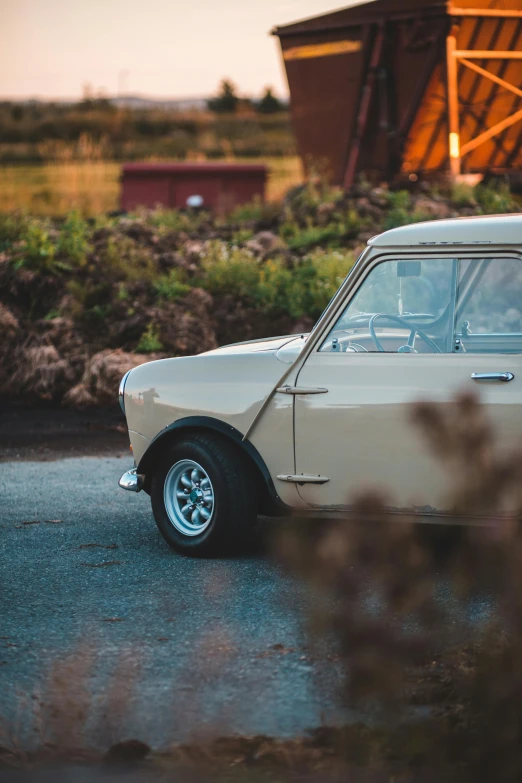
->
368, 214, 522, 247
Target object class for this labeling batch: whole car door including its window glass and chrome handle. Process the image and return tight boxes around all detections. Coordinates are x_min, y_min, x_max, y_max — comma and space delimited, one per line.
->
295, 254, 522, 512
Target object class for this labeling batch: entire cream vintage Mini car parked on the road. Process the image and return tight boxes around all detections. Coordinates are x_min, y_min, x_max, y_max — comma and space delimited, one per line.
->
120, 215, 522, 552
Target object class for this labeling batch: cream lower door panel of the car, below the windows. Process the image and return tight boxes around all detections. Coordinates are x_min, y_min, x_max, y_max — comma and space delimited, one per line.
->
295, 353, 522, 513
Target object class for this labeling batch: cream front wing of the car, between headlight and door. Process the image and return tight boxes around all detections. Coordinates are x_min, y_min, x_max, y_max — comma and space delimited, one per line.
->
125, 352, 299, 504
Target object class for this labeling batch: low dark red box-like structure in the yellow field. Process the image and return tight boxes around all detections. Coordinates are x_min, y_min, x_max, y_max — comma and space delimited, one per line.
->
121, 163, 267, 212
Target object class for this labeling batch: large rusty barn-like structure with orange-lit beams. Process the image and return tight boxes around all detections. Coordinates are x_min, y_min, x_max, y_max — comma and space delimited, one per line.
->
273, 0, 522, 187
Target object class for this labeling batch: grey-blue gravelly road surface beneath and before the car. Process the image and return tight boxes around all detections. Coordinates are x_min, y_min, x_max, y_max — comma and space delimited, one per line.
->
0, 456, 343, 748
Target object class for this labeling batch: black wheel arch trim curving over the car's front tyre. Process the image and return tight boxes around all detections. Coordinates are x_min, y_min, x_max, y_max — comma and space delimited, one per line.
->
137, 416, 290, 515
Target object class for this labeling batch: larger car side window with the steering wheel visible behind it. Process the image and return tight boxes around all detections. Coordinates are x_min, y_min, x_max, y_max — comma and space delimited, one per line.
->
319, 258, 458, 353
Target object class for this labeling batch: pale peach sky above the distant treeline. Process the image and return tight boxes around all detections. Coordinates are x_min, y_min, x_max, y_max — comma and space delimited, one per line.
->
0, 0, 368, 98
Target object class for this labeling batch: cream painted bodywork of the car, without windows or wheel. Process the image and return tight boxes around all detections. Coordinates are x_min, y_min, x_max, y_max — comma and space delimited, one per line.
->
119, 215, 522, 513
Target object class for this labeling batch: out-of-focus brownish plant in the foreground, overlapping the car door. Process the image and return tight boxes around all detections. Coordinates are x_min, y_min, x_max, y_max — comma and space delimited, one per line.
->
278, 394, 522, 783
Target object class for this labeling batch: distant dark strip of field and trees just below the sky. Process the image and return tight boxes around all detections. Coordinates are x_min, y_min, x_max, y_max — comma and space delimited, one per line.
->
0, 93, 296, 164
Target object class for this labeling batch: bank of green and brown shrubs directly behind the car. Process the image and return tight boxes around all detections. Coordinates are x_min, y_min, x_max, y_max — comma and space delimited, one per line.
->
0, 182, 520, 405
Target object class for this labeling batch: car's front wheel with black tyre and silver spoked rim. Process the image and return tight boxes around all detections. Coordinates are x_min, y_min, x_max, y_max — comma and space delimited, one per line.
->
151, 434, 257, 555
